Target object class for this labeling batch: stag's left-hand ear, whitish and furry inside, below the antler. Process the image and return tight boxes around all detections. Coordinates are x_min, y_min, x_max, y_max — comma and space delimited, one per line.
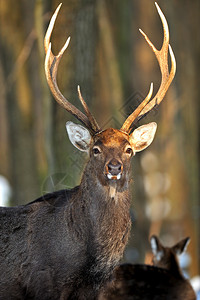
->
66, 122, 92, 152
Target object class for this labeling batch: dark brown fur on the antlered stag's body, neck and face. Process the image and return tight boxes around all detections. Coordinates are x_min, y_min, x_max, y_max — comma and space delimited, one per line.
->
0, 130, 131, 300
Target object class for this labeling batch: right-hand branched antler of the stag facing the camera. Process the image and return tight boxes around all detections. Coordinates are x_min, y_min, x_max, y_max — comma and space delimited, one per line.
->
121, 2, 176, 133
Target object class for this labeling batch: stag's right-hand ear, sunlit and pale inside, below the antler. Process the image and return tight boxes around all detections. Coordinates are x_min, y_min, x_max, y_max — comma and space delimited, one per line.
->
129, 122, 157, 152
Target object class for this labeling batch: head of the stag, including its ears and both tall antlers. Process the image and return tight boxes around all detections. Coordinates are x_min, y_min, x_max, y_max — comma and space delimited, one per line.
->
44, 4, 176, 190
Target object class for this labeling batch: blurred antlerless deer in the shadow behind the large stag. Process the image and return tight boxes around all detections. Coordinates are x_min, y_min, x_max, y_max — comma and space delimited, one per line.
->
99, 235, 196, 300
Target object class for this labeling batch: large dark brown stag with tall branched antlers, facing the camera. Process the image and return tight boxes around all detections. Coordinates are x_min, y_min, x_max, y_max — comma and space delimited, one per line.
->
0, 4, 176, 300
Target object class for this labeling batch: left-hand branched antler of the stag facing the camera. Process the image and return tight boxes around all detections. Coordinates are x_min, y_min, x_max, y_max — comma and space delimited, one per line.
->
44, 3, 100, 134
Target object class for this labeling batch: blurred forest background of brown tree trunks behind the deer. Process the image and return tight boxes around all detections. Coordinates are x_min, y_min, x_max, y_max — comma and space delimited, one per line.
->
0, 0, 200, 276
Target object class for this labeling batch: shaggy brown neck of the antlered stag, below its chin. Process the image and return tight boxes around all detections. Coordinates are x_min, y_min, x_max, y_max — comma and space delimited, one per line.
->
80, 165, 131, 274
